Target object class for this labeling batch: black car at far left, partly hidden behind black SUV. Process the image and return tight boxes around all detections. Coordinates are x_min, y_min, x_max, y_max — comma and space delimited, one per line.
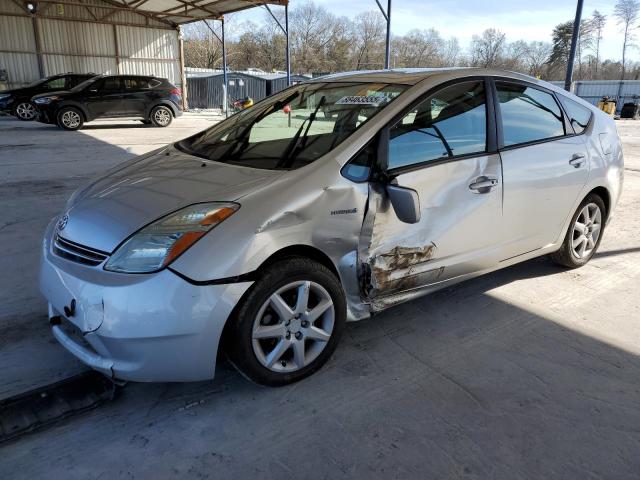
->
0, 73, 96, 120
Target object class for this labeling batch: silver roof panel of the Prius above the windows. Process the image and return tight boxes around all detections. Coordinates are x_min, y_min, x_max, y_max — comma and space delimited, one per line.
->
313, 67, 540, 85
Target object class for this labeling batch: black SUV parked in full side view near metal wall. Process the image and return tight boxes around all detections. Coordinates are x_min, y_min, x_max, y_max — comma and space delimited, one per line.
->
32, 75, 182, 130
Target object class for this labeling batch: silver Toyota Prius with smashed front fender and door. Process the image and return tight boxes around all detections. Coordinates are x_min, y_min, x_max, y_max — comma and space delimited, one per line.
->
40, 69, 623, 385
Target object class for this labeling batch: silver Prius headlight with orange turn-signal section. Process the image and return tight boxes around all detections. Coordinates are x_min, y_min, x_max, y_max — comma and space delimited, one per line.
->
104, 202, 240, 273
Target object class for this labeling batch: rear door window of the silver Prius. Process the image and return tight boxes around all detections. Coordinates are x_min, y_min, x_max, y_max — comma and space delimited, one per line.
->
496, 82, 565, 146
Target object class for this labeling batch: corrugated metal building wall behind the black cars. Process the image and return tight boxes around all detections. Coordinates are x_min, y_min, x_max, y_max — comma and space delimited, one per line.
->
0, 0, 182, 87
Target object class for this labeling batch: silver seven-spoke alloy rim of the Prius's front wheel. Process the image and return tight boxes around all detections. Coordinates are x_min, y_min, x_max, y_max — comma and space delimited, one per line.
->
252, 280, 335, 373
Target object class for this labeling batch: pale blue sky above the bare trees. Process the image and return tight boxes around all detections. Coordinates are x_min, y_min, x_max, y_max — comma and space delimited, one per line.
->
225, 0, 640, 61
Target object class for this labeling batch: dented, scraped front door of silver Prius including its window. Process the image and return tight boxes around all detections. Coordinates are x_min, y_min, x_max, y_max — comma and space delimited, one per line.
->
359, 81, 502, 304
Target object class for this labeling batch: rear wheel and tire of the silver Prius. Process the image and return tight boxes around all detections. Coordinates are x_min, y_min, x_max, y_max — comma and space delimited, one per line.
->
550, 194, 607, 268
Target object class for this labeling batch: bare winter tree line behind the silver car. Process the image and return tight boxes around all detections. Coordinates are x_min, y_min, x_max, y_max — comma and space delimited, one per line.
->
184, 0, 640, 80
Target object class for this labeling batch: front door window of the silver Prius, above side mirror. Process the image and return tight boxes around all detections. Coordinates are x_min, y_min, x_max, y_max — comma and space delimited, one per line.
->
388, 81, 487, 169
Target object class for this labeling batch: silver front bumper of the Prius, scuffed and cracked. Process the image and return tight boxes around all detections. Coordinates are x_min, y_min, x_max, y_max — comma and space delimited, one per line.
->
40, 222, 251, 381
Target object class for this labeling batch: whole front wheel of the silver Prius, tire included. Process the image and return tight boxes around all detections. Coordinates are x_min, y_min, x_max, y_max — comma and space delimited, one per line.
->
227, 257, 347, 386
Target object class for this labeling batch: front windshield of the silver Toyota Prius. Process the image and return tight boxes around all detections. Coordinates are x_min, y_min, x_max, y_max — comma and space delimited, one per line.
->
176, 82, 407, 169
